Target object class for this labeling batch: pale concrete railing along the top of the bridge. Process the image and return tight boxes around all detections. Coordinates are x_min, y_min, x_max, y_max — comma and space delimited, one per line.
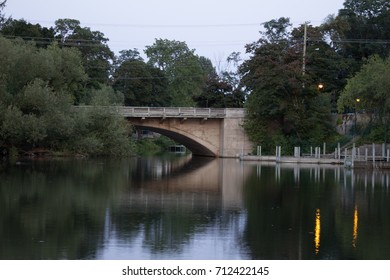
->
117, 106, 226, 118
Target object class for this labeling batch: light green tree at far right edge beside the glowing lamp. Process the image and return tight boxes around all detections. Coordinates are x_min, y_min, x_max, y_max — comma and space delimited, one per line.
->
338, 55, 390, 142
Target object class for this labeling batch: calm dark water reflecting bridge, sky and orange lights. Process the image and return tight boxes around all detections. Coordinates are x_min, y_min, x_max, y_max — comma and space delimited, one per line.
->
0, 157, 390, 260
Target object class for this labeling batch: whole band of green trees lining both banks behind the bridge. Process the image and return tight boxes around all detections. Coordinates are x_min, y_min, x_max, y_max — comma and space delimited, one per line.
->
0, 0, 390, 154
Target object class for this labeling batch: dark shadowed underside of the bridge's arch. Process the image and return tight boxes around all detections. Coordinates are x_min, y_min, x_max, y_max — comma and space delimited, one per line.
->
134, 124, 218, 157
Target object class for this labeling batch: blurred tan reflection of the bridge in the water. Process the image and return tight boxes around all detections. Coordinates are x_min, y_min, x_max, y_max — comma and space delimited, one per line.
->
123, 155, 249, 209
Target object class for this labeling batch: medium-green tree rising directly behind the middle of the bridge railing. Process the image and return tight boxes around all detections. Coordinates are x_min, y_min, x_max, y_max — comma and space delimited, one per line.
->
145, 39, 211, 106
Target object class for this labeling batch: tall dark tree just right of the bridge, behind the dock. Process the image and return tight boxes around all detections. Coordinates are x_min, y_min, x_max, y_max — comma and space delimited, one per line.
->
239, 18, 333, 152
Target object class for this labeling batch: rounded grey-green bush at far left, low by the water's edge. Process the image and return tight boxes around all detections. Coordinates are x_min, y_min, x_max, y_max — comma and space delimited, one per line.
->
0, 79, 71, 148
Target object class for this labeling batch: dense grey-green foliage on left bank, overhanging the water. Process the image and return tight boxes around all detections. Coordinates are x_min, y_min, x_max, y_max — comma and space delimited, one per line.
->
0, 36, 133, 155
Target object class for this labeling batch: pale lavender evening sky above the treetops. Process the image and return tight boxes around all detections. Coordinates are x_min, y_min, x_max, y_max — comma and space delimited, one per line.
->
3, 0, 344, 63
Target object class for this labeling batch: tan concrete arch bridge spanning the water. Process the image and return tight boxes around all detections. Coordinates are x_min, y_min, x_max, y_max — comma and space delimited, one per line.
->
117, 106, 252, 157
